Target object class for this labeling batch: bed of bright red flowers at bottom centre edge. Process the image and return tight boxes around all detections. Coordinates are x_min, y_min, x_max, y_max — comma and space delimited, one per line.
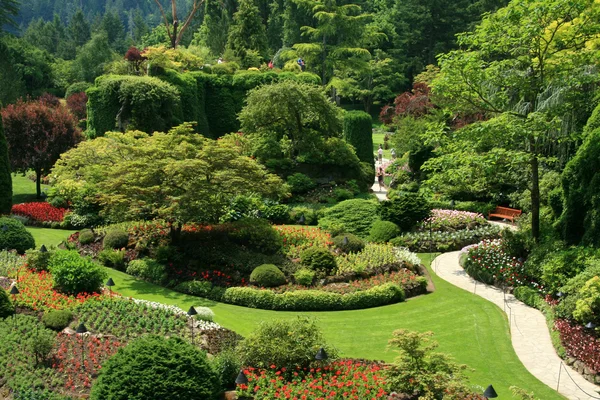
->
237, 360, 387, 400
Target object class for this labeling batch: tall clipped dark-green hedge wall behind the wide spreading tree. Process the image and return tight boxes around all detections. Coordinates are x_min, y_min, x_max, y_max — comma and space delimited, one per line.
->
87, 70, 321, 138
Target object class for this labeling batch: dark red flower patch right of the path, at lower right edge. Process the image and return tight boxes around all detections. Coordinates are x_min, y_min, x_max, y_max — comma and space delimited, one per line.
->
554, 319, 600, 371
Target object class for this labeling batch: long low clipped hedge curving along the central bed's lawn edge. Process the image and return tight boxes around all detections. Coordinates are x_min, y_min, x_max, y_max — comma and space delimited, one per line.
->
175, 281, 405, 311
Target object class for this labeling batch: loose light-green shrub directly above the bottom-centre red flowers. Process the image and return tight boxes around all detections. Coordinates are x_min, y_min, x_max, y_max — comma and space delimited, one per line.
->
238, 317, 337, 371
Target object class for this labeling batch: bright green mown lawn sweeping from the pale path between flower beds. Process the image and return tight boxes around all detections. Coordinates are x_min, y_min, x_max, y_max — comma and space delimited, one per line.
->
101, 255, 564, 400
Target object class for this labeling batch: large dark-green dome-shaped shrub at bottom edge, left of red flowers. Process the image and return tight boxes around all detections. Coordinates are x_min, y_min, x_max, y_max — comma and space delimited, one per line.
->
90, 336, 220, 400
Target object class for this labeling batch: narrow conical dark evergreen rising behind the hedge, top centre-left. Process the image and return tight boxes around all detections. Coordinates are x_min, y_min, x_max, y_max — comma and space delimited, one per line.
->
227, 0, 267, 67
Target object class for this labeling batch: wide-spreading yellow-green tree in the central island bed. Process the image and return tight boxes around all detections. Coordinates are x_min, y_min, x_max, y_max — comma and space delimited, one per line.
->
52, 123, 286, 241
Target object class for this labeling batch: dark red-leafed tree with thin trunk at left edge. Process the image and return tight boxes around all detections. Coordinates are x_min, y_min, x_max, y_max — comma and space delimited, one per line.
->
2, 100, 83, 198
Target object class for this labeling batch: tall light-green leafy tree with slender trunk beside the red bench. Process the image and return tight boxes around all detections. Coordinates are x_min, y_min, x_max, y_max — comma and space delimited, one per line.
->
433, 0, 600, 240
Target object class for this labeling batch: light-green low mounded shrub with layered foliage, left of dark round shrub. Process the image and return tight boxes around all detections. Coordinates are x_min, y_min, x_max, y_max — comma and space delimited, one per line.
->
319, 199, 380, 238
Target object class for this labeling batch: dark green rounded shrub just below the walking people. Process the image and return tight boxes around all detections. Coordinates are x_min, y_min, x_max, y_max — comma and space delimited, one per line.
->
378, 193, 431, 232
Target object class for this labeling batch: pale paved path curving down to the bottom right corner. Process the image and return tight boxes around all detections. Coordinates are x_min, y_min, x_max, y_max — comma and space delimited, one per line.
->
432, 251, 600, 400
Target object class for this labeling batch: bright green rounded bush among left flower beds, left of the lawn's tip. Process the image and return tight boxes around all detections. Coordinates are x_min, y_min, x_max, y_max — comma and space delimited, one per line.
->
48, 250, 107, 295
